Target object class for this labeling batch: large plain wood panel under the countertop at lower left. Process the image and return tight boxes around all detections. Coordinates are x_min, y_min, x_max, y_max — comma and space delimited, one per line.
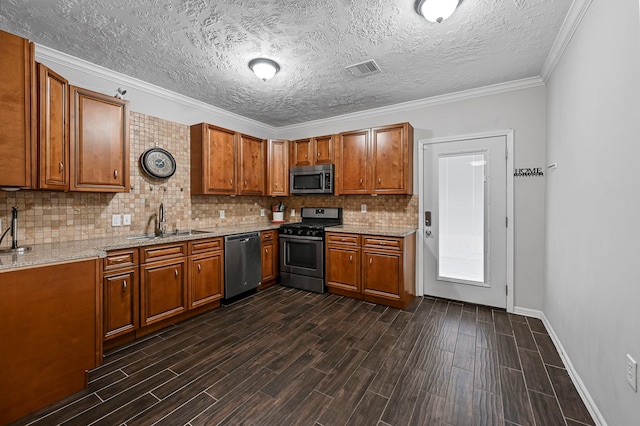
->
0, 258, 102, 425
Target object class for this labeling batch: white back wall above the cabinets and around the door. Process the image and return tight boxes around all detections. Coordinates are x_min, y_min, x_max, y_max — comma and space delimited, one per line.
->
278, 85, 546, 311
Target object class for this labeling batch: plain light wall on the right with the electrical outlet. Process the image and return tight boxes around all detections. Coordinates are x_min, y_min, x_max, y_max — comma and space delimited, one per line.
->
543, 0, 640, 426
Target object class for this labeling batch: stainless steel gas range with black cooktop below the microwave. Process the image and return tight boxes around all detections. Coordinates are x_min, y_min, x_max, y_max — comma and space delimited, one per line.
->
278, 207, 342, 293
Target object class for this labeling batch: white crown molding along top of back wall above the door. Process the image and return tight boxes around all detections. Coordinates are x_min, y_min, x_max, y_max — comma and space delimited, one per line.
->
276, 77, 544, 132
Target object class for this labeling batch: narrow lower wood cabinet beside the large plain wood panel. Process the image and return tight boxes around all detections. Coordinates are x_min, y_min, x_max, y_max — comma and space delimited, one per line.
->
102, 249, 140, 340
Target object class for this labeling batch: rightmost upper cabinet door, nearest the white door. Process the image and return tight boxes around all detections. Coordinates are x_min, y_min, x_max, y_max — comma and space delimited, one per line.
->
371, 123, 413, 194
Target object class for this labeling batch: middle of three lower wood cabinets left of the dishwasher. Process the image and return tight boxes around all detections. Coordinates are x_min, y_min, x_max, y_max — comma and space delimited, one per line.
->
140, 243, 188, 326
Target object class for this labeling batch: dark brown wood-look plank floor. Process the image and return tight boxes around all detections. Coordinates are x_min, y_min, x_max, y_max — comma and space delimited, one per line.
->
16, 286, 594, 426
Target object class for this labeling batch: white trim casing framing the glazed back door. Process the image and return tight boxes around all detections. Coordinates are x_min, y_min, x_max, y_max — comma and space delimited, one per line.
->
416, 129, 515, 312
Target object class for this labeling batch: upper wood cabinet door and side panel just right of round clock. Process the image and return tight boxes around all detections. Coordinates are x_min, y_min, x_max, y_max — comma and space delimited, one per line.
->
191, 123, 238, 195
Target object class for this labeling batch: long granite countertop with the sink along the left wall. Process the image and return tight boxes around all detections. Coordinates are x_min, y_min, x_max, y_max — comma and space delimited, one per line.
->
0, 222, 280, 271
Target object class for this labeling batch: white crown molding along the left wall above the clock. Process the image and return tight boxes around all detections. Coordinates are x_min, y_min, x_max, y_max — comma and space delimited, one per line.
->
36, 44, 276, 134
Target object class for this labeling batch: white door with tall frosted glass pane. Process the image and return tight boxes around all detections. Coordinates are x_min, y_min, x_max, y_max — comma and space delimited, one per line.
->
420, 136, 507, 308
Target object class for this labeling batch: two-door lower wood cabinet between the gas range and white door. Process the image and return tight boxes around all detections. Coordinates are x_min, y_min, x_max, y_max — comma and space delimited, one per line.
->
325, 232, 415, 309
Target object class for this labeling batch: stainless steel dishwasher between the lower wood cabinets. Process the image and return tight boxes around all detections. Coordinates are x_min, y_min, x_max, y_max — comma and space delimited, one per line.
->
224, 232, 262, 299
